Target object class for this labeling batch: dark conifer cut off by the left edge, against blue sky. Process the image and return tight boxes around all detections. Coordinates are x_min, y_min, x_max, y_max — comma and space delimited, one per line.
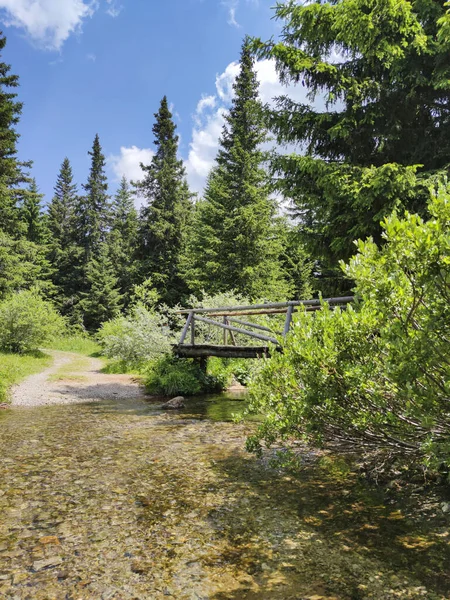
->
0, 32, 30, 238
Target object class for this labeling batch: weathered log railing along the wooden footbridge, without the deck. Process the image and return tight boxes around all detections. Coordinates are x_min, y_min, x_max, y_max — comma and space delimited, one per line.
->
177, 296, 354, 347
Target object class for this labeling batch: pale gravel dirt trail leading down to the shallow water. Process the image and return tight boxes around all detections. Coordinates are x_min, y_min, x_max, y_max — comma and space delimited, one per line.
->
12, 350, 144, 406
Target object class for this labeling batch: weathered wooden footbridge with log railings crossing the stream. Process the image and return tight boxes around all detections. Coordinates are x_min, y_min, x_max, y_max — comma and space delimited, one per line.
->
174, 296, 354, 359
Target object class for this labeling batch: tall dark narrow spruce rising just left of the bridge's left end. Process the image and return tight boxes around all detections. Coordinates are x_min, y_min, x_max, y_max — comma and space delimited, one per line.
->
137, 96, 192, 305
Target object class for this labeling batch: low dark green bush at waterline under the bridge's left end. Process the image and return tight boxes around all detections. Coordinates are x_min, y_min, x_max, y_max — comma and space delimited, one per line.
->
145, 355, 227, 396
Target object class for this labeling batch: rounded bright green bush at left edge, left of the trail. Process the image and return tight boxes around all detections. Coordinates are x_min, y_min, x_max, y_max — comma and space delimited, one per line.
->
0, 290, 65, 353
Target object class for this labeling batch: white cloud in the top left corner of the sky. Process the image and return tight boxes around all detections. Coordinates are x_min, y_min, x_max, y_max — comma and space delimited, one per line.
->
0, 0, 97, 50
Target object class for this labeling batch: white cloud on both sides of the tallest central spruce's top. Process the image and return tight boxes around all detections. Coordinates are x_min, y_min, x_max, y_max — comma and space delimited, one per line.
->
186, 60, 307, 192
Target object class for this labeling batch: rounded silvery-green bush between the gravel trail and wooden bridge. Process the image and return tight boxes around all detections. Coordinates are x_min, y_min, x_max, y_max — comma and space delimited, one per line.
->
97, 304, 175, 367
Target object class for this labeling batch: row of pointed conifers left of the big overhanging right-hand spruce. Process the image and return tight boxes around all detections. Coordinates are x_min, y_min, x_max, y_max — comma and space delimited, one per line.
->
0, 38, 311, 331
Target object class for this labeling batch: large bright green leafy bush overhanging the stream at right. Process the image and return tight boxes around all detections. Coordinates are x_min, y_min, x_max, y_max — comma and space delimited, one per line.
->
248, 190, 450, 466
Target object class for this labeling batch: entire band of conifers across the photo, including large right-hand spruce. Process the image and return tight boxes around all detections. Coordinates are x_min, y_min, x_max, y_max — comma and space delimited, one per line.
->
0, 0, 450, 330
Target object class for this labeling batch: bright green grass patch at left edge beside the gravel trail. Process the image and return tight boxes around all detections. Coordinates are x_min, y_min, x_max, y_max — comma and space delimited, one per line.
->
0, 352, 52, 402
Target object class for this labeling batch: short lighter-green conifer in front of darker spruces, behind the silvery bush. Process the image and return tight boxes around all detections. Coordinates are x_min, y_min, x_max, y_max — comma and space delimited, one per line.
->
80, 244, 121, 331
